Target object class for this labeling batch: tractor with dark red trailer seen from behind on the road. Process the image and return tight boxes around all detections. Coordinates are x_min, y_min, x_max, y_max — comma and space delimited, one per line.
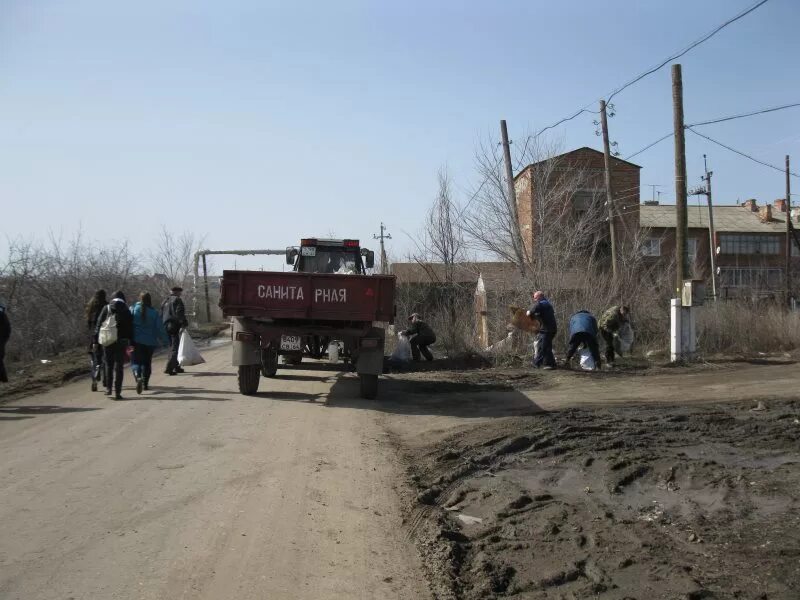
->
219, 238, 395, 399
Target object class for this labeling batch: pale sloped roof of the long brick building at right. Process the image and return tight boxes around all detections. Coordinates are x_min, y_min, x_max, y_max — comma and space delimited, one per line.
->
639, 204, 786, 233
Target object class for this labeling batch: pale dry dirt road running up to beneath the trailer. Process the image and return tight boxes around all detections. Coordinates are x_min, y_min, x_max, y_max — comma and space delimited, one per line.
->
0, 346, 429, 600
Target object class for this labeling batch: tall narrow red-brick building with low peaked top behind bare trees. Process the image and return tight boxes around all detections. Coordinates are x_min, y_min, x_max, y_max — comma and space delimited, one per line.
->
514, 147, 641, 256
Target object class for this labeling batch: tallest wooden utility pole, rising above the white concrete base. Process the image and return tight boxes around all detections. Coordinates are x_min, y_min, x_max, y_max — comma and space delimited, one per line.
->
672, 65, 689, 296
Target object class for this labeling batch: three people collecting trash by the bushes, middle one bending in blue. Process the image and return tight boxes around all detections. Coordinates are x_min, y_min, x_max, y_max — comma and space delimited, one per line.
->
525, 291, 630, 370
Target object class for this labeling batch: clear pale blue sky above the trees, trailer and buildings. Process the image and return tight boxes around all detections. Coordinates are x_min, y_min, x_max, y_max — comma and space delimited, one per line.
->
0, 0, 800, 266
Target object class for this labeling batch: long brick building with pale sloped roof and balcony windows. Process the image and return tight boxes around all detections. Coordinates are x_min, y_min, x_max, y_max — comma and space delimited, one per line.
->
639, 198, 800, 298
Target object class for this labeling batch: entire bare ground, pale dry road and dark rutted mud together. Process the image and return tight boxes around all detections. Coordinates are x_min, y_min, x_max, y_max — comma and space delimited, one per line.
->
0, 346, 800, 600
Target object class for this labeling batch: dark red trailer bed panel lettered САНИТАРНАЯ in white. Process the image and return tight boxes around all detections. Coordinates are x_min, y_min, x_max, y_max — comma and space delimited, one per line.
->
219, 270, 395, 322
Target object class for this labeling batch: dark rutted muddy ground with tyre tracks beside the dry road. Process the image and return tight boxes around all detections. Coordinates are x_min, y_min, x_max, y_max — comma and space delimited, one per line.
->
408, 400, 800, 599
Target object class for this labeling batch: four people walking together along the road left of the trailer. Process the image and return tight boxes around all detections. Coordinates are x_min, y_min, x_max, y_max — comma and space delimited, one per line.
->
86, 286, 189, 400
